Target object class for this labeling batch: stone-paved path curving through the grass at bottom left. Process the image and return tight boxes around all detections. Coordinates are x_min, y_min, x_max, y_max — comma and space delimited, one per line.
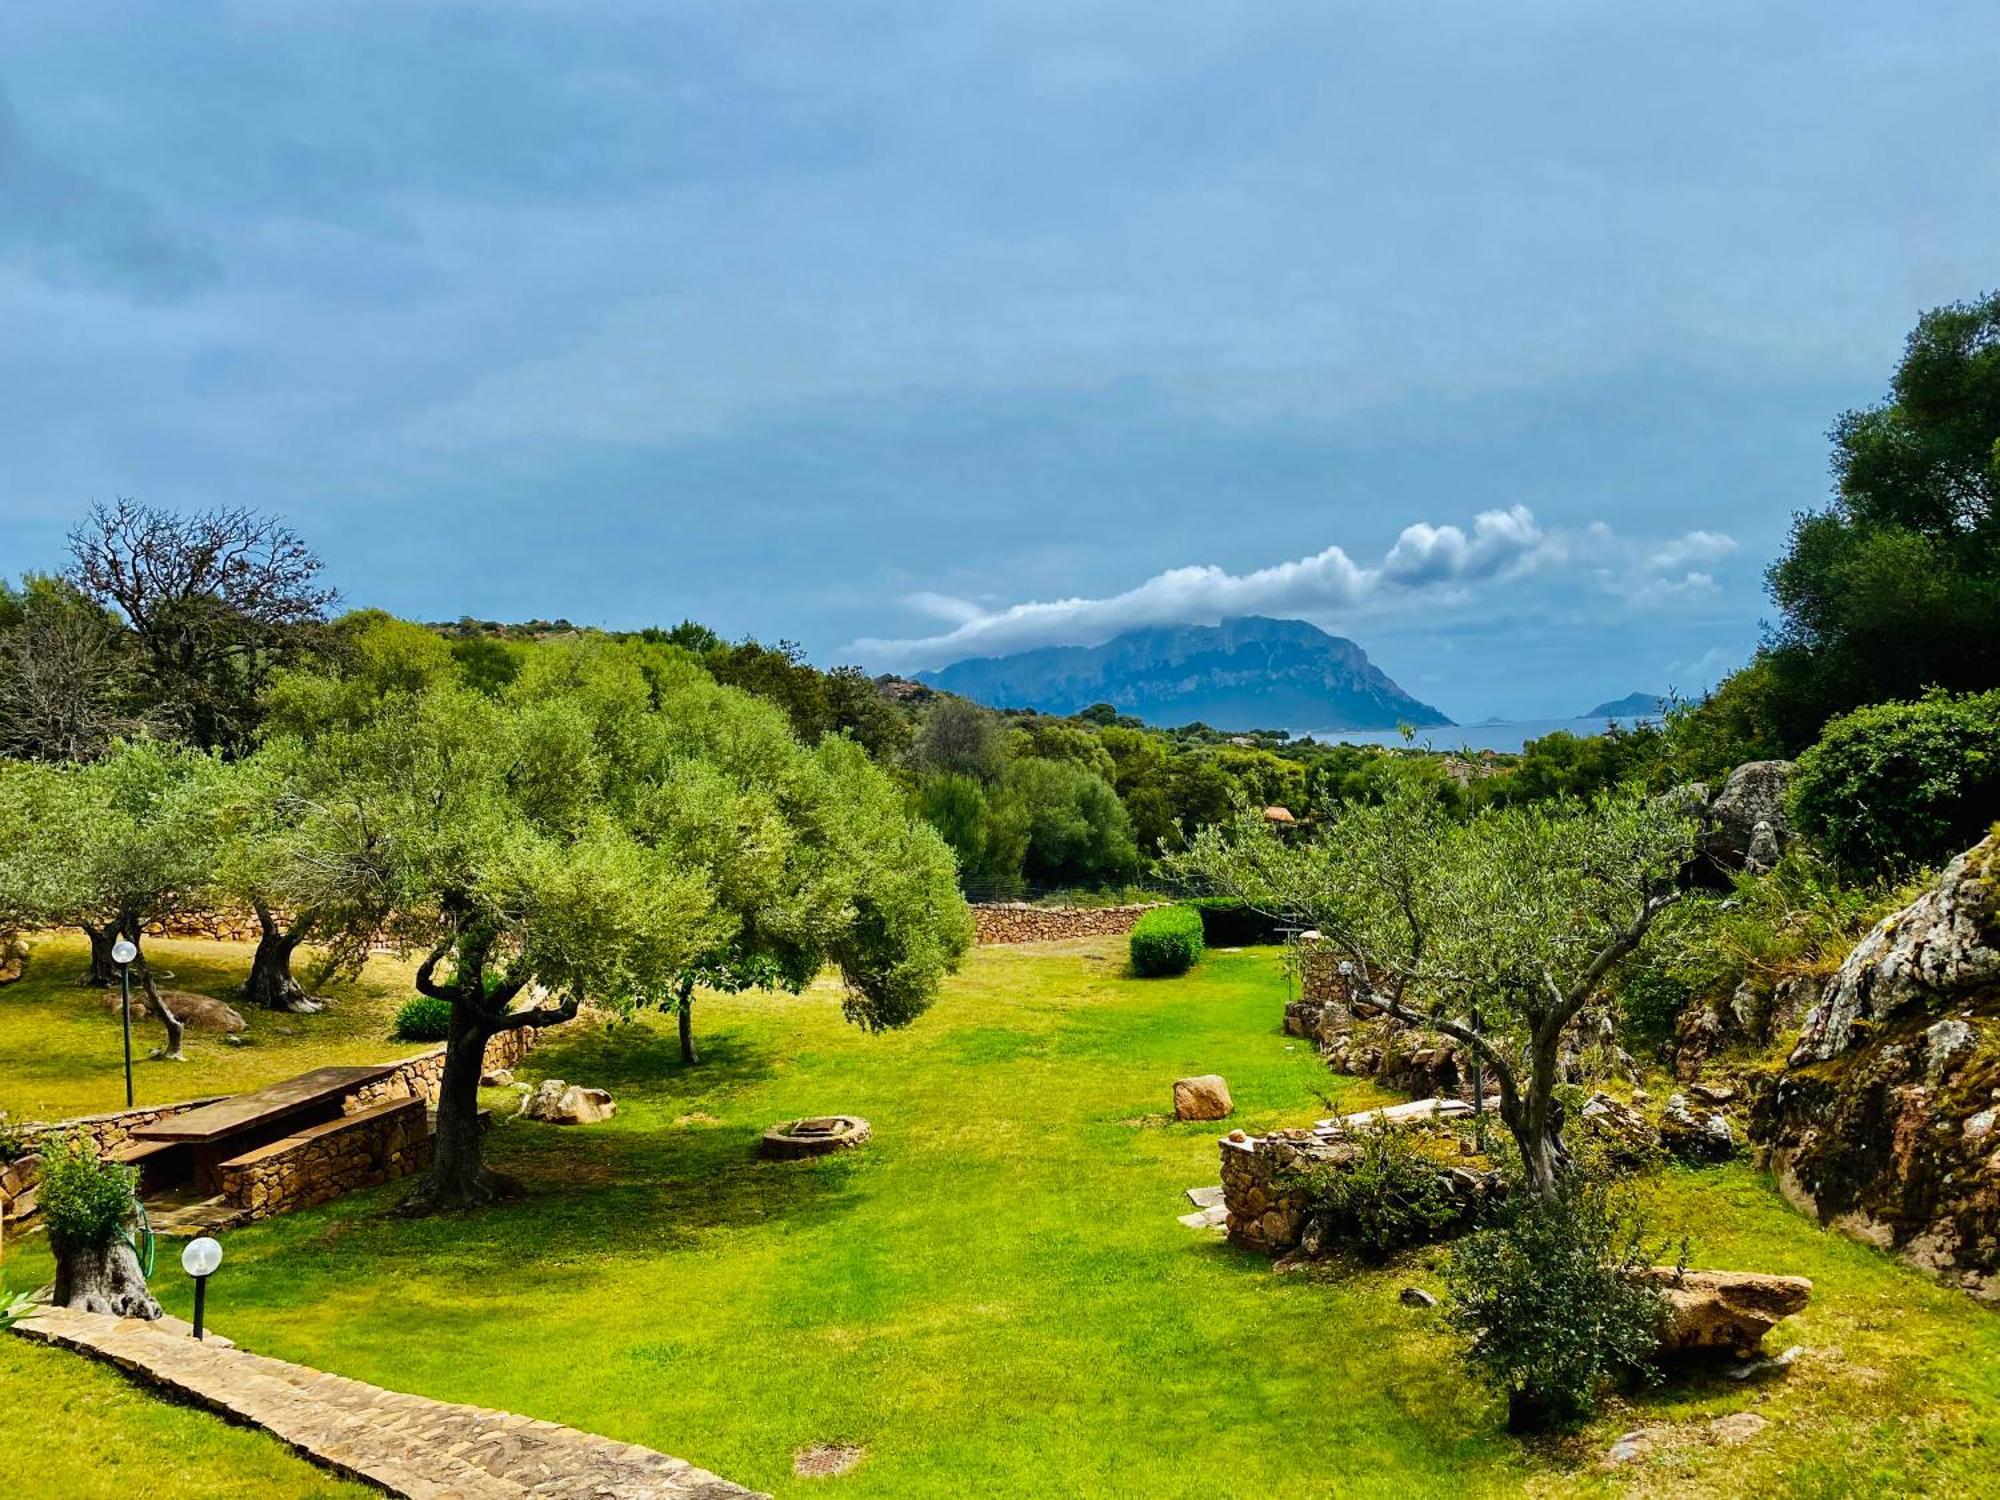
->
16, 1308, 768, 1500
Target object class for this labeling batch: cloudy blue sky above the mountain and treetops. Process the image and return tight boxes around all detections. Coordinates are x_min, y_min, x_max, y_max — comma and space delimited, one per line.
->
0, 0, 2000, 720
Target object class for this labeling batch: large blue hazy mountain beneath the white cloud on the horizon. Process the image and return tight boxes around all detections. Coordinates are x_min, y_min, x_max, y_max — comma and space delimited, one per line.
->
916, 614, 1452, 730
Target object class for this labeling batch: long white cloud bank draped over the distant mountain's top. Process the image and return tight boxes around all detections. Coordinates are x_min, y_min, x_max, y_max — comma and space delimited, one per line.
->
848, 506, 1736, 670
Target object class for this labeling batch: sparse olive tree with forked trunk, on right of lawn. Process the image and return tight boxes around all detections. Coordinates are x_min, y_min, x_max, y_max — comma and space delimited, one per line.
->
1166, 776, 1694, 1198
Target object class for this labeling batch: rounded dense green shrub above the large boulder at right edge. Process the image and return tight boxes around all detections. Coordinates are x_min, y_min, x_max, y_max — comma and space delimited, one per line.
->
1792, 692, 2000, 876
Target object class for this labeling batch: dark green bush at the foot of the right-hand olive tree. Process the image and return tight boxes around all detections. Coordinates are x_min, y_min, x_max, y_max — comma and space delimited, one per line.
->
1446, 1172, 1664, 1432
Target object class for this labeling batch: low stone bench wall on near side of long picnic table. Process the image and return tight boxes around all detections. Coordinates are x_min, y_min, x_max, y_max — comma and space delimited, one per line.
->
220, 1096, 432, 1224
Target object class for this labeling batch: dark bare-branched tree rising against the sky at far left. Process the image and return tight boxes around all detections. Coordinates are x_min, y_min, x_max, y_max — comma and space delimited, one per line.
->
68, 500, 338, 750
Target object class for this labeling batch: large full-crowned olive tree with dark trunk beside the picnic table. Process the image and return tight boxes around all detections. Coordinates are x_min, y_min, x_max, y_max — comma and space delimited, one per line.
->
268, 640, 970, 1210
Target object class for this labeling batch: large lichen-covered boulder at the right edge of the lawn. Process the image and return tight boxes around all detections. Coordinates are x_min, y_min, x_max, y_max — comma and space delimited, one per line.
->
1750, 836, 2000, 1302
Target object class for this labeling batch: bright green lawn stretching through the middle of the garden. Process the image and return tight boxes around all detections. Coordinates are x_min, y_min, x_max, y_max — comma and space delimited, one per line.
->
0, 940, 2000, 1496
